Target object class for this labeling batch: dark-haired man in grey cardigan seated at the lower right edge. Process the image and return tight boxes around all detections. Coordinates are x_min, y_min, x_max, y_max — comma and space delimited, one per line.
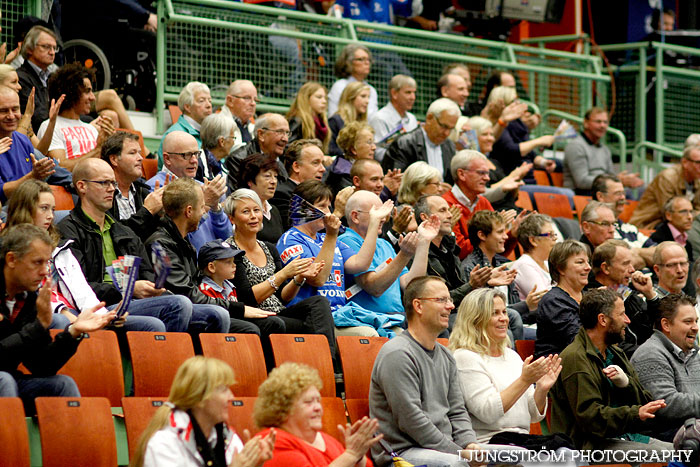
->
631, 294, 700, 437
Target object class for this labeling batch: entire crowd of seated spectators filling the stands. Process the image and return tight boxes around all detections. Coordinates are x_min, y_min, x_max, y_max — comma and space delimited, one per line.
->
0, 13, 700, 466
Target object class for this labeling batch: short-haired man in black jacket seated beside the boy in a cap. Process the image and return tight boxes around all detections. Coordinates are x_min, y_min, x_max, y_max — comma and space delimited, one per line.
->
146, 177, 285, 335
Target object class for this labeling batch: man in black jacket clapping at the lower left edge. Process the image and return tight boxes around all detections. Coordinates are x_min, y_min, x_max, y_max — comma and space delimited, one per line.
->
0, 224, 115, 414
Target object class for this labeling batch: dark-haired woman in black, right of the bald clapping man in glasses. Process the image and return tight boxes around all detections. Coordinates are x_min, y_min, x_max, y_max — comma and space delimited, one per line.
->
241, 153, 284, 243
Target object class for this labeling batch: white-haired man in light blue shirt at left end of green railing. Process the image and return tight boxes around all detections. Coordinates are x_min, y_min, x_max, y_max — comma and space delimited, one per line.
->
158, 81, 212, 169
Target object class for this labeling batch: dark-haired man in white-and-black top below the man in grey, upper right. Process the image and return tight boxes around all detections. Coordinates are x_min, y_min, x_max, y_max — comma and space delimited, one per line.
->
591, 174, 657, 269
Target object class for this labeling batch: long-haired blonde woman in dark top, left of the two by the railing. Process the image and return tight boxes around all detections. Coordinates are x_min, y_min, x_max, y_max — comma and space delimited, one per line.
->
287, 81, 331, 154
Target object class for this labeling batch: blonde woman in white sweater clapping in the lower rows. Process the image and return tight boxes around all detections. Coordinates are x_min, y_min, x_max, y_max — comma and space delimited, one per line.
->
449, 288, 561, 443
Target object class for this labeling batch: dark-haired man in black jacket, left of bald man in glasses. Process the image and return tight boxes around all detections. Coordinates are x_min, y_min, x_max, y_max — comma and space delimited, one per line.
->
102, 131, 163, 239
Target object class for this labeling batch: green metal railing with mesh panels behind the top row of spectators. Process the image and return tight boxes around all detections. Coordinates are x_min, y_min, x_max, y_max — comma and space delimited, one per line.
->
157, 0, 610, 132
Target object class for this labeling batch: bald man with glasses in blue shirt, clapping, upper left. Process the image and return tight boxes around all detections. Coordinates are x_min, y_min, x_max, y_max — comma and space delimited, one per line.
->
146, 131, 232, 254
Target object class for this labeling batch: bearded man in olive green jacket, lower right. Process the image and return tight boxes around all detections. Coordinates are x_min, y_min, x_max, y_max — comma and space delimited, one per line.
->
550, 289, 673, 452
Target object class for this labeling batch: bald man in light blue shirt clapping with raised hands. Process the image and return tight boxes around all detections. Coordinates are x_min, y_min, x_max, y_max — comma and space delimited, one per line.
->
338, 190, 440, 326
